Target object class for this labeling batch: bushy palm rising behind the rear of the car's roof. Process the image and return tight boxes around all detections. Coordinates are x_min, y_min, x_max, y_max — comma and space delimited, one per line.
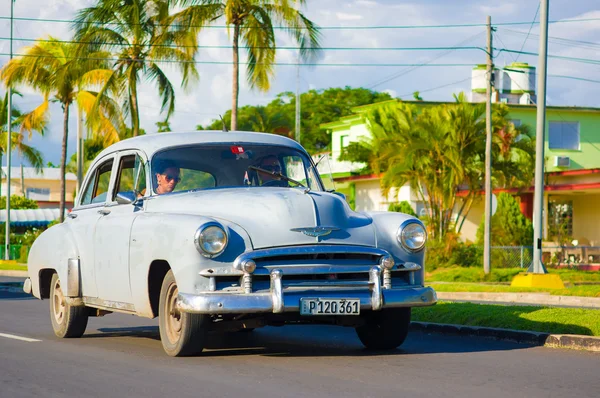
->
74, 0, 199, 136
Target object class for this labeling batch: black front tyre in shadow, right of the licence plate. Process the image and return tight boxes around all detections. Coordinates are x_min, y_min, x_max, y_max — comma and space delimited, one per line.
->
356, 308, 410, 350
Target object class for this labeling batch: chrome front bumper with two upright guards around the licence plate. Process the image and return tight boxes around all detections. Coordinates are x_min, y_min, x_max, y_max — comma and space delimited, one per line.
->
177, 267, 437, 314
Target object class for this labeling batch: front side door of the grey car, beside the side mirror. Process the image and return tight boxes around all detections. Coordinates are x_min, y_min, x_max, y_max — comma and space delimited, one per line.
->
94, 151, 147, 304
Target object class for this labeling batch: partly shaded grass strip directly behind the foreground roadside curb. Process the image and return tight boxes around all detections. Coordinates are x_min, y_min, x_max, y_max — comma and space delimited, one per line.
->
412, 302, 600, 336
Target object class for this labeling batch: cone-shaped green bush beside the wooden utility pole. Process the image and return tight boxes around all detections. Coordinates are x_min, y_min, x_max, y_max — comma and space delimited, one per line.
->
477, 192, 533, 246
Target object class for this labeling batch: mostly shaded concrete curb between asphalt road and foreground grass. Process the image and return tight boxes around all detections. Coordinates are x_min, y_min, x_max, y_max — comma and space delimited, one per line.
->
410, 322, 600, 352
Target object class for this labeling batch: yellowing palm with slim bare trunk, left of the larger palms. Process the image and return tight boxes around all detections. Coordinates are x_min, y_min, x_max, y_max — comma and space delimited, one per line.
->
1, 37, 111, 222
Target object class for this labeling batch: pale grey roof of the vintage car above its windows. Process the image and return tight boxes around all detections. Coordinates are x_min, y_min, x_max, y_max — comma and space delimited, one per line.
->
96, 130, 306, 159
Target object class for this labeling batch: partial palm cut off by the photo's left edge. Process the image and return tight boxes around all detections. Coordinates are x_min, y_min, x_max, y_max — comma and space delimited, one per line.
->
0, 90, 48, 175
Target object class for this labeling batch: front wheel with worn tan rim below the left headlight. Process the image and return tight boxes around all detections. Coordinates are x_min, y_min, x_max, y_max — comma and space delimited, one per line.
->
158, 271, 210, 357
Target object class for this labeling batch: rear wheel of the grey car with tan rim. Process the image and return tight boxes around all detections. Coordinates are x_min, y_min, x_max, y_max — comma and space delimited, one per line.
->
50, 274, 88, 338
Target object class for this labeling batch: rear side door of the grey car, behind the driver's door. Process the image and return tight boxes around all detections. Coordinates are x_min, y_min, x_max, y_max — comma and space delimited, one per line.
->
66, 155, 114, 297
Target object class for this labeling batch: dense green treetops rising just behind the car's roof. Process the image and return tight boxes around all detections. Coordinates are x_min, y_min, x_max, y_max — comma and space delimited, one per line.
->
196, 86, 391, 152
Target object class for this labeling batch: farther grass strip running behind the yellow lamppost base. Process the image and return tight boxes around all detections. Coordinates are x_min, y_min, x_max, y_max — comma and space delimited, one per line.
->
425, 267, 600, 283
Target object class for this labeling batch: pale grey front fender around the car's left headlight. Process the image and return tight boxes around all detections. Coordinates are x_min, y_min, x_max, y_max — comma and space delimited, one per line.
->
129, 213, 252, 317
